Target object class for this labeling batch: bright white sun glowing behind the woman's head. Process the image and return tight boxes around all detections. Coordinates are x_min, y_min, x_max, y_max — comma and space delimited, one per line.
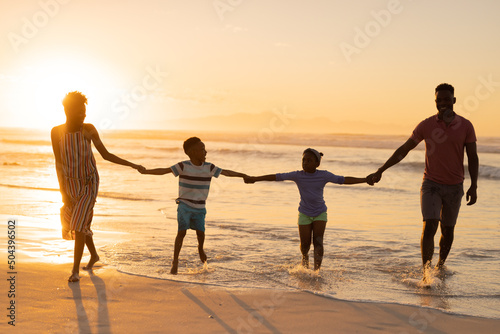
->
18, 59, 116, 129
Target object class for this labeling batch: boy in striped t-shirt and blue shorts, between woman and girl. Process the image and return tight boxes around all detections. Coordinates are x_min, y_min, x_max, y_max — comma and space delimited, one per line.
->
140, 137, 247, 275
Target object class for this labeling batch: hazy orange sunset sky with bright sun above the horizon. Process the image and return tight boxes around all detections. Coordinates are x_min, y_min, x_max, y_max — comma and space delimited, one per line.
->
0, 0, 500, 136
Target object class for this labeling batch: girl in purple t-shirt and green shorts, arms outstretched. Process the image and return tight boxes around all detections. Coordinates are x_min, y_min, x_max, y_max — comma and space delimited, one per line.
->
245, 148, 366, 270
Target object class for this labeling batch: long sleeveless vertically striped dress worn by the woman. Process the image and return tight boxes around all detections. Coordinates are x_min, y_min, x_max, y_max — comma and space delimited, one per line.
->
59, 130, 99, 240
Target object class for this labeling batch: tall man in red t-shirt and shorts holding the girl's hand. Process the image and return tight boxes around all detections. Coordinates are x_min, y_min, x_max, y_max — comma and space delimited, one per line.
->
367, 83, 479, 276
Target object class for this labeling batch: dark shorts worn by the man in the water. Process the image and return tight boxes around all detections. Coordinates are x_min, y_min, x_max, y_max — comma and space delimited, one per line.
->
420, 179, 464, 226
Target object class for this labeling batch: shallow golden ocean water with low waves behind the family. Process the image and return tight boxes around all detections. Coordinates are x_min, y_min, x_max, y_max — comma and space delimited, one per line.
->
0, 128, 500, 319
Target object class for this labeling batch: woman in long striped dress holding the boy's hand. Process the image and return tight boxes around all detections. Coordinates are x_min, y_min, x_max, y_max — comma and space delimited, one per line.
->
51, 91, 144, 282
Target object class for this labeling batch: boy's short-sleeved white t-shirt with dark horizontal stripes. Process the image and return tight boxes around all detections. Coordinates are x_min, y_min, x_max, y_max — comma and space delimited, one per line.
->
170, 160, 222, 209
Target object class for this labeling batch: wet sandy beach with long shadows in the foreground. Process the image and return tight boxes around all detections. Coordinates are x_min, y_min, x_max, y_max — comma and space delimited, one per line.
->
1, 262, 500, 333
